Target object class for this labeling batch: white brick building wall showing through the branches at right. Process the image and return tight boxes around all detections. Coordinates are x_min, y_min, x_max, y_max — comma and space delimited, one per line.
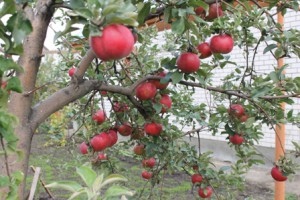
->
195, 12, 300, 149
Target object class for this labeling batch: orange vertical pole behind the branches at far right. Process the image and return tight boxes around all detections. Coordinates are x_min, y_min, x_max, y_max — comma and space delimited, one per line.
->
274, 12, 285, 200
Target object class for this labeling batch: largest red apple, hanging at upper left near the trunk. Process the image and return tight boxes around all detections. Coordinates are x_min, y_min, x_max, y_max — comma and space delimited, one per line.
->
90, 24, 134, 61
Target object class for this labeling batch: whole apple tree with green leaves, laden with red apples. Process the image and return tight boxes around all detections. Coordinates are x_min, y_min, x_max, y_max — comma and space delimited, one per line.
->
0, 0, 300, 199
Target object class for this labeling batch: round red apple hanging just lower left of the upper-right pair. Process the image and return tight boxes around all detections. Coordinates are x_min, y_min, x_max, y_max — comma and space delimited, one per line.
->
176, 52, 200, 73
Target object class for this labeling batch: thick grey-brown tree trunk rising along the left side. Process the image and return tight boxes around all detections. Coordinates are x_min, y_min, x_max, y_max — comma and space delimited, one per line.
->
0, 0, 53, 199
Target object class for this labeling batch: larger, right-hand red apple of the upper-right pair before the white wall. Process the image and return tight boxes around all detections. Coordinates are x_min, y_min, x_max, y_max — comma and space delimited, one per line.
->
209, 34, 234, 54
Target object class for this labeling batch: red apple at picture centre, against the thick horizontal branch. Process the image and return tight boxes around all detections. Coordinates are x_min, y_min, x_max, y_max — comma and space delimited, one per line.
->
135, 82, 156, 100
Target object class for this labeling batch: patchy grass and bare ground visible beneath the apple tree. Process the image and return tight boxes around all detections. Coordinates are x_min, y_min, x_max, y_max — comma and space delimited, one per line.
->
27, 134, 300, 200
